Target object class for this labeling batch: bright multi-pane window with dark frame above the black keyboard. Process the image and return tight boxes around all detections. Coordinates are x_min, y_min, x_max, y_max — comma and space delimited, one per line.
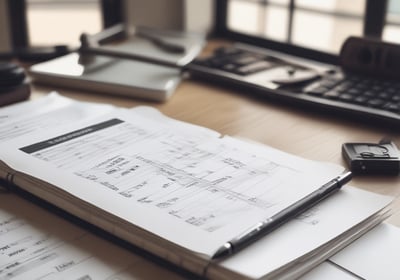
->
217, 0, 392, 62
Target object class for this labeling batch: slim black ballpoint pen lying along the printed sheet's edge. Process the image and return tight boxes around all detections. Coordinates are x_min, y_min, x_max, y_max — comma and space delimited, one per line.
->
212, 172, 352, 259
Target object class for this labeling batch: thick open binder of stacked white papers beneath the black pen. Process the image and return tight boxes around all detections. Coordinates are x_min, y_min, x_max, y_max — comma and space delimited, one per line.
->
0, 94, 391, 279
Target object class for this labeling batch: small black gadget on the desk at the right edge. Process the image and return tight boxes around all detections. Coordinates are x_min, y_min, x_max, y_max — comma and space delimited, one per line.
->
342, 141, 400, 175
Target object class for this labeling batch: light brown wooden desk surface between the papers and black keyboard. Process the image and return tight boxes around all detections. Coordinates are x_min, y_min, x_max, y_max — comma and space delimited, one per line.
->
32, 53, 400, 226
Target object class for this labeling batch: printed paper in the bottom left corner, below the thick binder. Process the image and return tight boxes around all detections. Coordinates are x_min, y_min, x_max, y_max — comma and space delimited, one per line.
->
0, 194, 184, 280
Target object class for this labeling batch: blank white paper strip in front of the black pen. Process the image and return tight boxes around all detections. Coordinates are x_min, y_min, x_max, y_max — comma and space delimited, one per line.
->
214, 186, 392, 279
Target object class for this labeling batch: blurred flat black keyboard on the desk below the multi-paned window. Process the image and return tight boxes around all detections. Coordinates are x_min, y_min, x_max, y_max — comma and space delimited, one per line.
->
187, 44, 400, 125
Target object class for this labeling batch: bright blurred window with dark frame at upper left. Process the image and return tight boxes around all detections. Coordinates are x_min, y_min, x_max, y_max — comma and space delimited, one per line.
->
7, 0, 123, 49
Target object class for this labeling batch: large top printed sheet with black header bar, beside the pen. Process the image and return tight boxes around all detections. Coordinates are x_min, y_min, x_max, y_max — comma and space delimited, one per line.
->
1, 110, 343, 256
